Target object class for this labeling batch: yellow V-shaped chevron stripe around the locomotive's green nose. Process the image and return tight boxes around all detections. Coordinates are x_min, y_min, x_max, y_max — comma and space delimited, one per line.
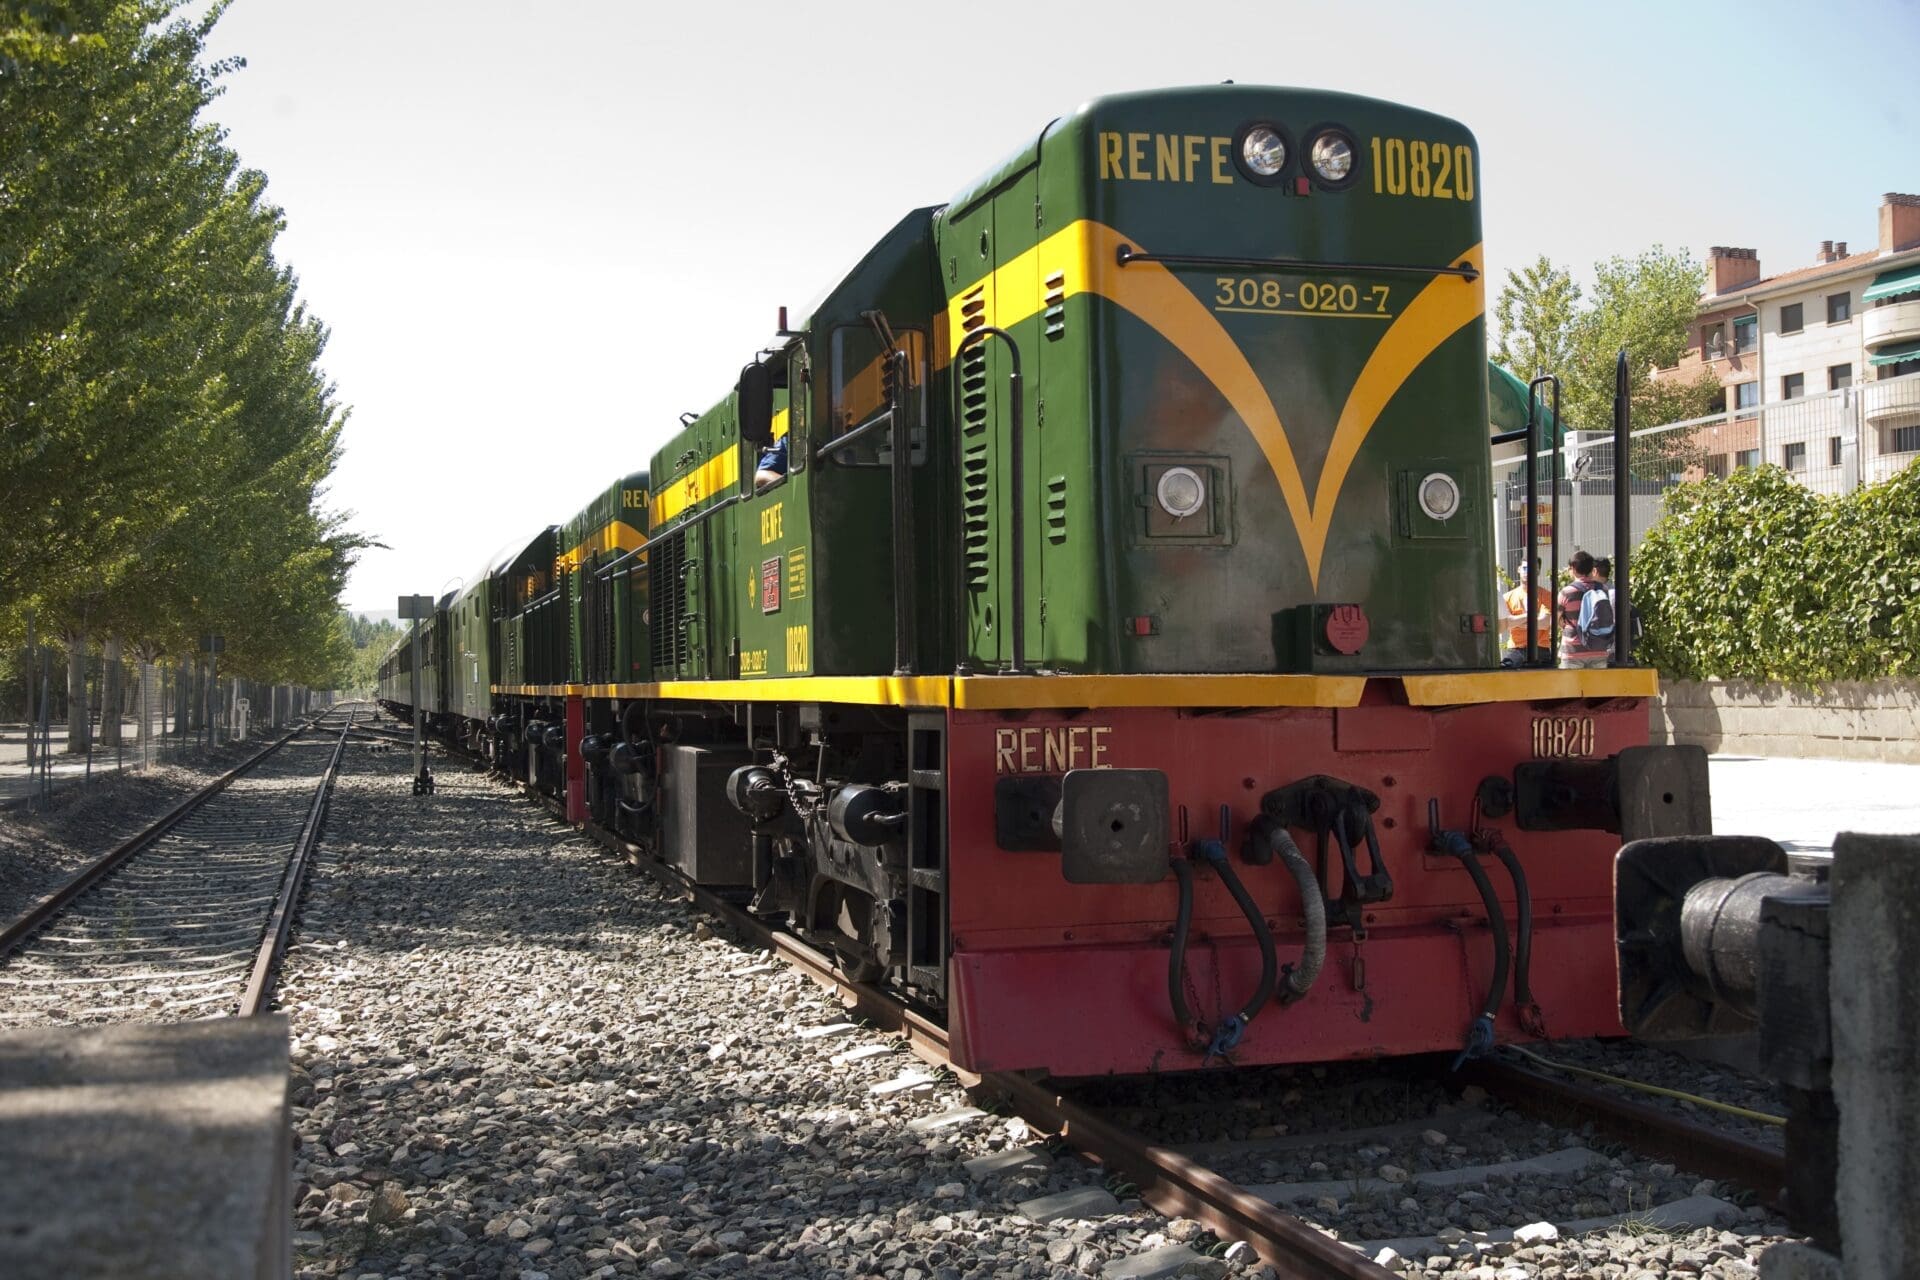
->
947, 219, 1486, 589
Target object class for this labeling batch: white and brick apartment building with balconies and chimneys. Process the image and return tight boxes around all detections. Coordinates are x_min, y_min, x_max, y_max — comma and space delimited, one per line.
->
1657, 192, 1920, 489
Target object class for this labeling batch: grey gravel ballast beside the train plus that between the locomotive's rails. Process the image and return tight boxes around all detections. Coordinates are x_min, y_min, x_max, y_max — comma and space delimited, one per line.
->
280, 743, 1804, 1280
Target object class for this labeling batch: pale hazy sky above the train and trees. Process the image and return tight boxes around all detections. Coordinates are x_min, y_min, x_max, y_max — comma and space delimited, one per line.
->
198, 0, 1920, 610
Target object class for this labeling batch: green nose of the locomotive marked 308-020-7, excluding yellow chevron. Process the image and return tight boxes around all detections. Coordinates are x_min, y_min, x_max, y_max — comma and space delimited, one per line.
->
937, 86, 1494, 672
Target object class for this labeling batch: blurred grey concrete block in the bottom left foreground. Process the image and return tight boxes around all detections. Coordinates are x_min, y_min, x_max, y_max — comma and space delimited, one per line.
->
0, 1015, 292, 1280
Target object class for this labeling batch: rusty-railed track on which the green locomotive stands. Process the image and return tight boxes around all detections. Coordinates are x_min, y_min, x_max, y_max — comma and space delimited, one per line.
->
534, 793, 1786, 1280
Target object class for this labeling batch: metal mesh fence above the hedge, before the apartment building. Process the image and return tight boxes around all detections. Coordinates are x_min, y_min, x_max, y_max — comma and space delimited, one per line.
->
1494, 374, 1920, 576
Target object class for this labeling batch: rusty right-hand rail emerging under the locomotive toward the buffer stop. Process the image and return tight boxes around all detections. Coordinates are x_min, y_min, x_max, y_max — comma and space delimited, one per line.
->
1455, 1059, 1788, 1203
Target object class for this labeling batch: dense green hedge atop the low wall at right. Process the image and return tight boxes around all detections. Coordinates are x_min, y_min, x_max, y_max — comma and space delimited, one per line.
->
1630, 466, 1920, 685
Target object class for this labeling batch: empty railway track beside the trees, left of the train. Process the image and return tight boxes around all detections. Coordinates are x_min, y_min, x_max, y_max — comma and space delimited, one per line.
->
0, 704, 361, 1029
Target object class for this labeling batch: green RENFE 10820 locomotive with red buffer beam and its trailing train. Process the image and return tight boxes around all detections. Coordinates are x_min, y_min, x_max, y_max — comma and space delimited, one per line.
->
382, 84, 1705, 1075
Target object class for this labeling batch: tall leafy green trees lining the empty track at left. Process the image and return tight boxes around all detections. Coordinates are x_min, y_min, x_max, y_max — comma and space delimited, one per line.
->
0, 0, 367, 744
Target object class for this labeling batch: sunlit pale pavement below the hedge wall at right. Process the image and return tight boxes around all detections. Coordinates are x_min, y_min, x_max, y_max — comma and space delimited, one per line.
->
1709, 756, 1920, 858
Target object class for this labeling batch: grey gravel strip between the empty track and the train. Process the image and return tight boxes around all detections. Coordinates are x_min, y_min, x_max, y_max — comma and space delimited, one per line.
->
280, 743, 1221, 1280
